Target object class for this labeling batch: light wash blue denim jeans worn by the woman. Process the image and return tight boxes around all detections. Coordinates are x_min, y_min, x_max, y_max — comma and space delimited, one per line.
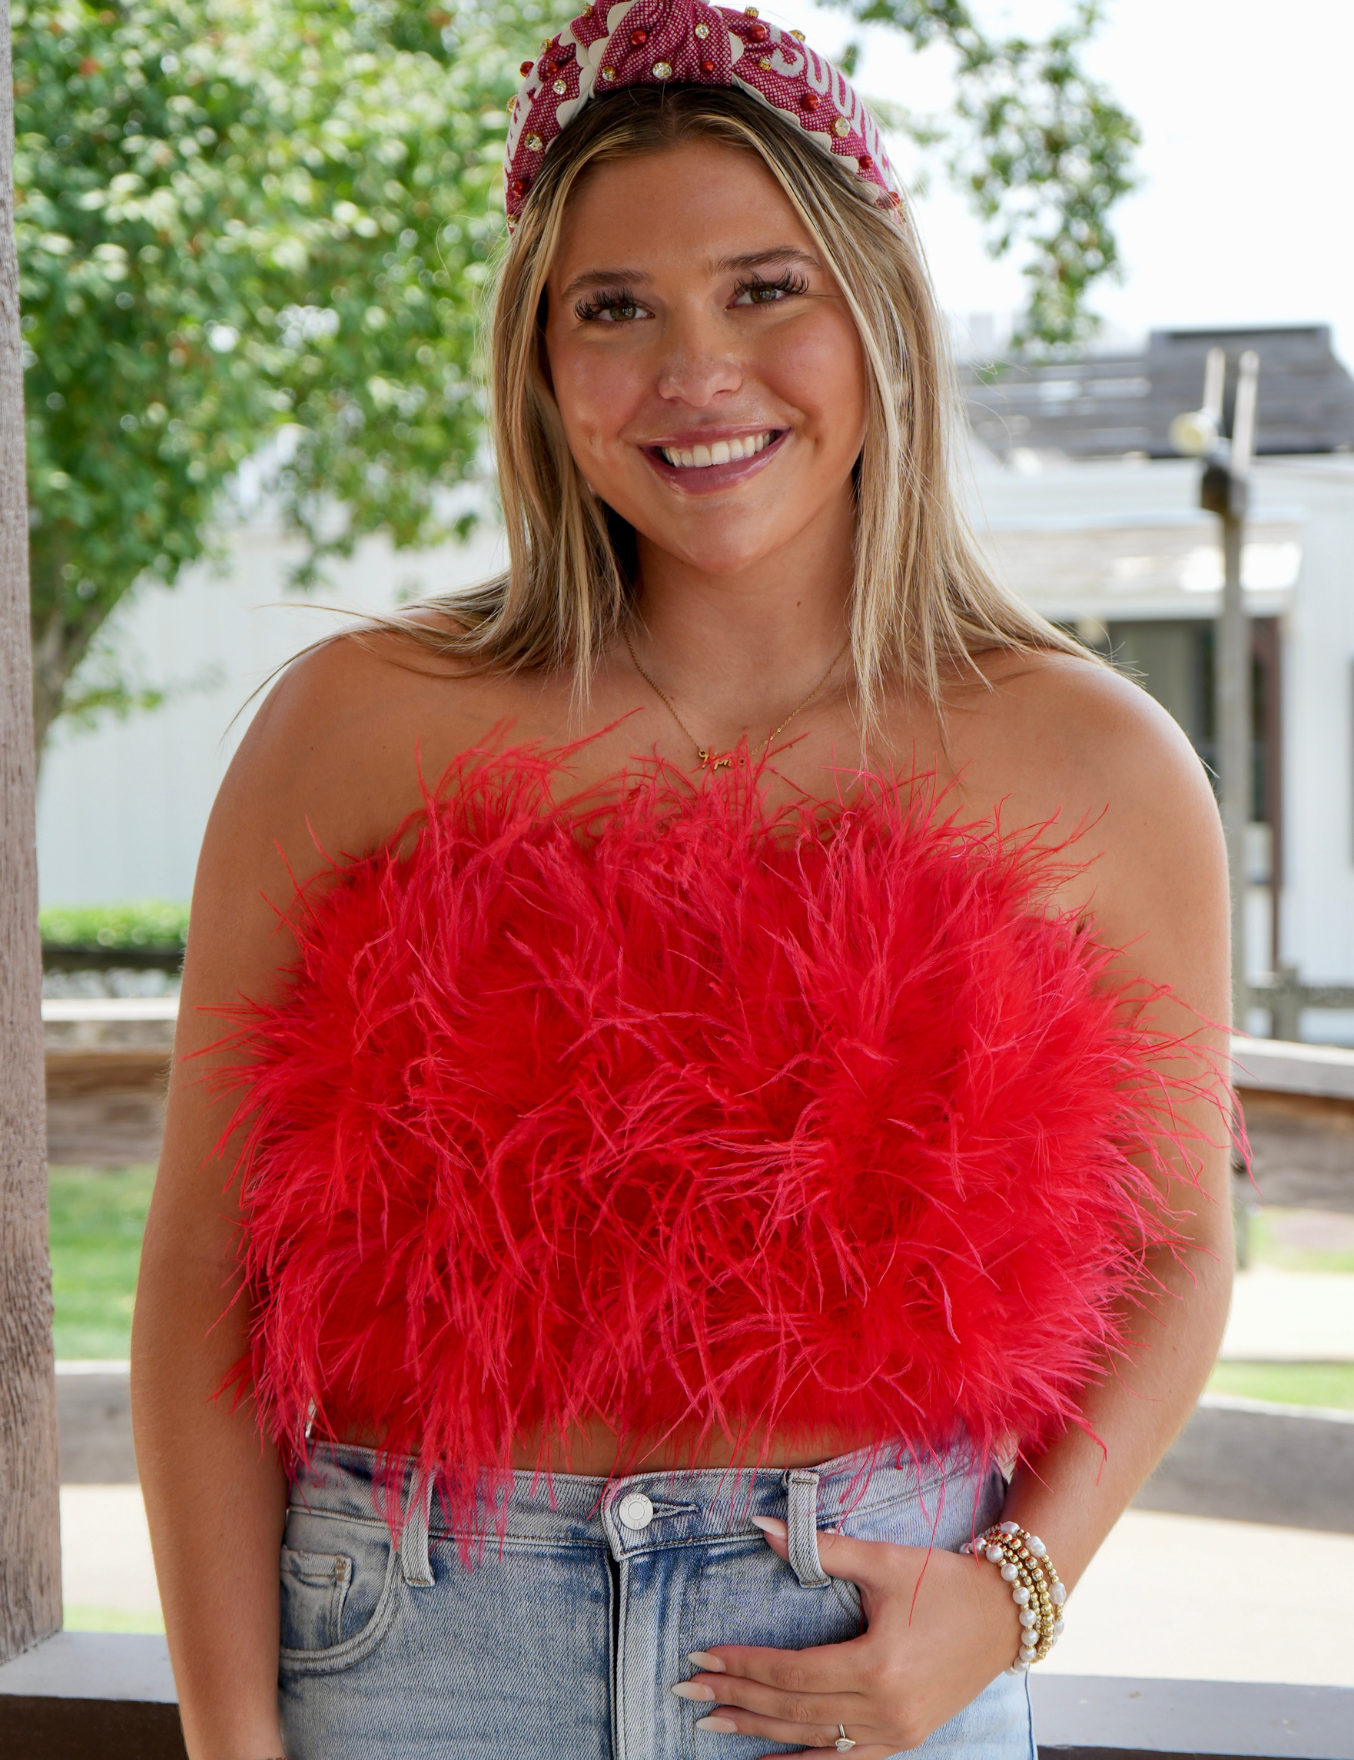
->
280, 1445, 1034, 1760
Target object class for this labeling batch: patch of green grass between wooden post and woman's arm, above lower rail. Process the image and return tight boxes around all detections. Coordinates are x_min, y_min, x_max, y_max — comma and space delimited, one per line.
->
48, 1167, 155, 1358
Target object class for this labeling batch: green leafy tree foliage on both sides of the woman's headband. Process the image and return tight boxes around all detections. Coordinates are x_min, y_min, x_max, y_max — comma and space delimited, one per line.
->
21, 0, 1134, 748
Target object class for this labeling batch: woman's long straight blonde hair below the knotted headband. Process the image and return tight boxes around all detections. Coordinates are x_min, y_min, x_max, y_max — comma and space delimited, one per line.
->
373, 86, 1086, 729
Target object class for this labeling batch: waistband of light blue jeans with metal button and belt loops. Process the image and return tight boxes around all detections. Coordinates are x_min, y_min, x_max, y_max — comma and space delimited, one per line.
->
291, 1443, 991, 1584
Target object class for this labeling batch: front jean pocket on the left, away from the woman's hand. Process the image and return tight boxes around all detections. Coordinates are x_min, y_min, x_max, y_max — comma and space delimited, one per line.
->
280, 1508, 400, 1674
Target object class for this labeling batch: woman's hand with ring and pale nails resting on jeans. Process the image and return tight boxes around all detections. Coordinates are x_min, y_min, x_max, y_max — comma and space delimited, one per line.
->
676, 1522, 1019, 1760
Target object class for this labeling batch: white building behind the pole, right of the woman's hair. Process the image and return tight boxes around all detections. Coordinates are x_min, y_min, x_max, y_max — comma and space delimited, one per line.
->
974, 449, 1354, 1030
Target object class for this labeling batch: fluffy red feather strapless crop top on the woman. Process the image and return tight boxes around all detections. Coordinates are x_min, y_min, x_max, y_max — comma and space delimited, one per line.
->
216, 748, 1211, 1512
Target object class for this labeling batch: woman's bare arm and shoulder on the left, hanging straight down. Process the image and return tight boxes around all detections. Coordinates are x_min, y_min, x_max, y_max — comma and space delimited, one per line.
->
132, 642, 464, 1760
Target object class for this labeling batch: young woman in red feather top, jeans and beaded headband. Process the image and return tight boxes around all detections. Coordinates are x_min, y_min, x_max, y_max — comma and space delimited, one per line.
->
134, 0, 1231, 1760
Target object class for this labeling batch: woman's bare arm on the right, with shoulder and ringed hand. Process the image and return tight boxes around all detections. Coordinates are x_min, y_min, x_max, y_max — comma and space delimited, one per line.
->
676, 667, 1233, 1760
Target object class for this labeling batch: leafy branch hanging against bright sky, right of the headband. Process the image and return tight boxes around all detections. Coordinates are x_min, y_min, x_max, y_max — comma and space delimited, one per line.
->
829, 0, 1139, 354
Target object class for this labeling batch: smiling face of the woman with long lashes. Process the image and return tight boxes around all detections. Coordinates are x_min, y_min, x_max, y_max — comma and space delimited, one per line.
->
546, 139, 868, 576
